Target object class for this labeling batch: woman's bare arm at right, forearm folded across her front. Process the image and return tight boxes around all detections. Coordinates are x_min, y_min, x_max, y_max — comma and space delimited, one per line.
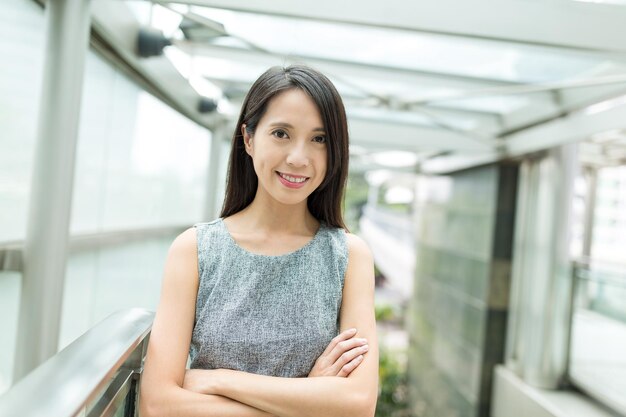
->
182, 235, 378, 417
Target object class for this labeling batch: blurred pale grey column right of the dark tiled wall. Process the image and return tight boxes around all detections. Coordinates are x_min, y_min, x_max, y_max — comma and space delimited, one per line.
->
507, 144, 578, 389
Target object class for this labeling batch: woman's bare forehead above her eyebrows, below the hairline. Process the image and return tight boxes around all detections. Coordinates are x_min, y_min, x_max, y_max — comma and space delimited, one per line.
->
259, 88, 324, 130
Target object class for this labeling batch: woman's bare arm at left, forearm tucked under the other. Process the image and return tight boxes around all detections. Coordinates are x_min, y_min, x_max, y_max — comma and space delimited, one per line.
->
139, 229, 270, 417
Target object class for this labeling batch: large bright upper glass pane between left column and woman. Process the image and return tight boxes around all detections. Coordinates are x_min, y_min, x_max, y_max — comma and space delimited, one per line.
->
71, 50, 210, 233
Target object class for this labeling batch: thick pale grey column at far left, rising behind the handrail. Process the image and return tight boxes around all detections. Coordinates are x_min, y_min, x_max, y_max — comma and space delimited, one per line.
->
14, 0, 90, 381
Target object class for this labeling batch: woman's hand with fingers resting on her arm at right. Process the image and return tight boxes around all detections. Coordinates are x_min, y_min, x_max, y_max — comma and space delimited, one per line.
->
309, 329, 369, 377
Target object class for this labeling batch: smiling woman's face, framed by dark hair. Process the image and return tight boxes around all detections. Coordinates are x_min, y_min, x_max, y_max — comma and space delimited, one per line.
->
242, 88, 327, 204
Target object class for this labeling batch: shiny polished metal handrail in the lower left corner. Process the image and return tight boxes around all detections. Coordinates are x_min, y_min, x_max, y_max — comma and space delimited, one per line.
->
0, 309, 154, 417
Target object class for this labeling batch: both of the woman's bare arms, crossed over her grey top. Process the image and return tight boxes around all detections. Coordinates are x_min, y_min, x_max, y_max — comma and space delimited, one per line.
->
140, 229, 378, 417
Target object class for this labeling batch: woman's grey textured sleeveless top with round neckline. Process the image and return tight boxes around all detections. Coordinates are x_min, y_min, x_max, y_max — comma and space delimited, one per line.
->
190, 219, 348, 377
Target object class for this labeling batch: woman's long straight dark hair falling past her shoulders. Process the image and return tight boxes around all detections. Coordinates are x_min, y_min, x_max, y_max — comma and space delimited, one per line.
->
221, 65, 348, 229
